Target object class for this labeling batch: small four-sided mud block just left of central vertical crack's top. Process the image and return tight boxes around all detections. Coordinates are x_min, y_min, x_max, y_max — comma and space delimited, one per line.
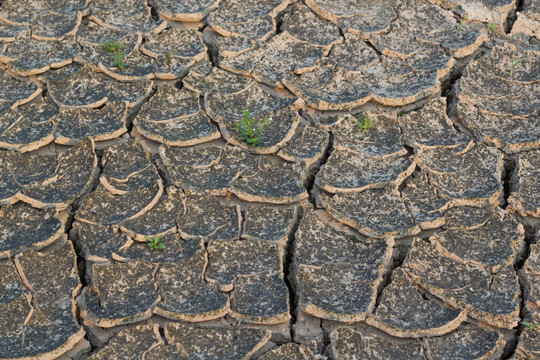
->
242, 206, 299, 244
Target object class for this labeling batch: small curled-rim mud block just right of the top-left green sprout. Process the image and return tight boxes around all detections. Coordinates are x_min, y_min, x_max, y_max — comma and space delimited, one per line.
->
99, 51, 155, 81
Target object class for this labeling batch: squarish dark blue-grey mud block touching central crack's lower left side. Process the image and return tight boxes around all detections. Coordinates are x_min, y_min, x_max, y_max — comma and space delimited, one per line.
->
231, 273, 291, 324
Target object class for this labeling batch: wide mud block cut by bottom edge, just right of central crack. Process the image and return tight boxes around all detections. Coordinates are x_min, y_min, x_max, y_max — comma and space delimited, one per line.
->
330, 327, 425, 360
